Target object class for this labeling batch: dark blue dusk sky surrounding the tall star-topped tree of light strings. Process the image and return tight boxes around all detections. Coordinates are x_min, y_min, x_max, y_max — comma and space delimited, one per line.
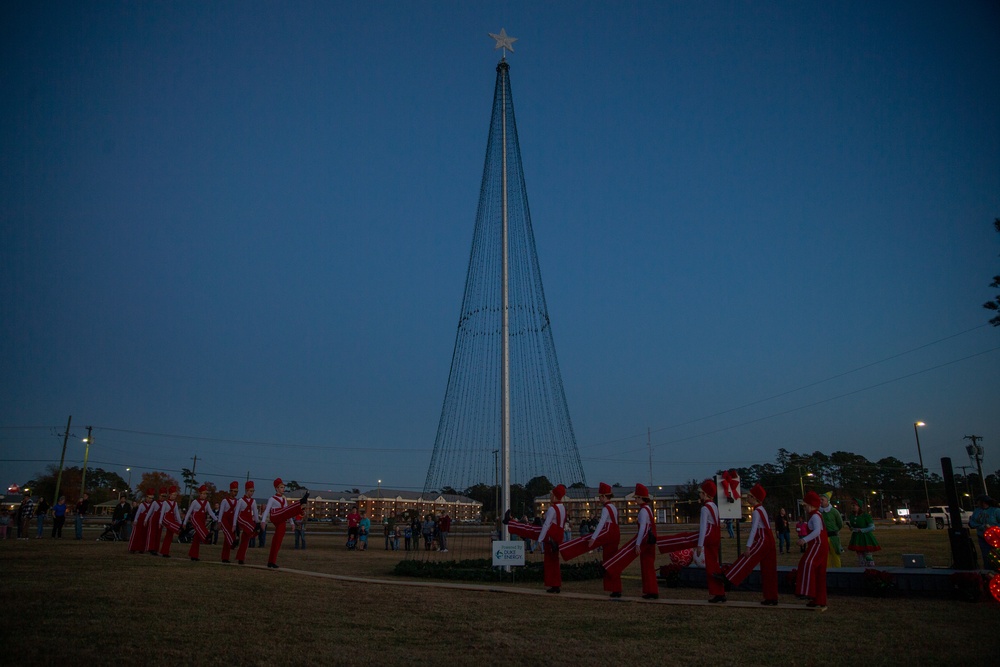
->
0, 1, 1000, 496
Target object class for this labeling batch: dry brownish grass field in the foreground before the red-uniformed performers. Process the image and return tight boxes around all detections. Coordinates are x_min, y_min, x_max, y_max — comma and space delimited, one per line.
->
0, 529, 1000, 665
